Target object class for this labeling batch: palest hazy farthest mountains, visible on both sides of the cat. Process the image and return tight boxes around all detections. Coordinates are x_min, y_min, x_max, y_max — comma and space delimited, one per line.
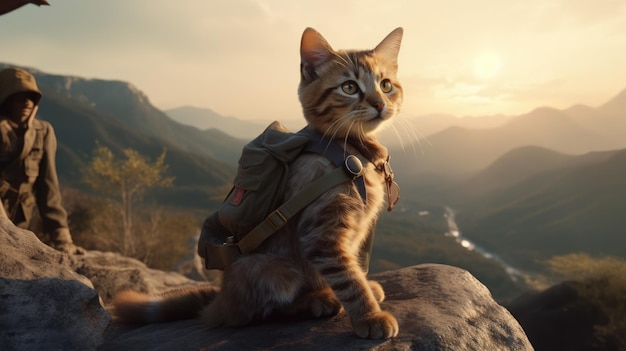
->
165, 82, 626, 188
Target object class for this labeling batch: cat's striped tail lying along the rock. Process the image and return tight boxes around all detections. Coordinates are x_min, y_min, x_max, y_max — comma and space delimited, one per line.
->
110, 285, 219, 324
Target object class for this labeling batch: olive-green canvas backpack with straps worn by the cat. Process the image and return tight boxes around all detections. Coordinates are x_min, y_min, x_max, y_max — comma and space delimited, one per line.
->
198, 121, 373, 271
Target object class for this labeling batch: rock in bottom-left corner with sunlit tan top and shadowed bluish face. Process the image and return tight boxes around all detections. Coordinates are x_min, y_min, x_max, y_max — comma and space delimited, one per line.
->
0, 218, 111, 350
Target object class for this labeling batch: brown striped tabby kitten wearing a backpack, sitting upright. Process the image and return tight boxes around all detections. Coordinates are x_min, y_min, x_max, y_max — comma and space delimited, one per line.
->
112, 28, 403, 339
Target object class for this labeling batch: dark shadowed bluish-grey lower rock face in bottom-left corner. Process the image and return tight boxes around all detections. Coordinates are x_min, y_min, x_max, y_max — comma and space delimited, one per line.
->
0, 278, 105, 350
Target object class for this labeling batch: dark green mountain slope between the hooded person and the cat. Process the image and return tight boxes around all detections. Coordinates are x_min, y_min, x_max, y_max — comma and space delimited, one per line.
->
0, 64, 240, 208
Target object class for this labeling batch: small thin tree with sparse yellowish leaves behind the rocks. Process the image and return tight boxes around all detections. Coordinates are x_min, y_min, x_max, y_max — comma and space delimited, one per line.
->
83, 145, 174, 255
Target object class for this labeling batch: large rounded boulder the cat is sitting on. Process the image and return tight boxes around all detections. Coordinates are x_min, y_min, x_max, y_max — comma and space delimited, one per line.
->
100, 264, 533, 351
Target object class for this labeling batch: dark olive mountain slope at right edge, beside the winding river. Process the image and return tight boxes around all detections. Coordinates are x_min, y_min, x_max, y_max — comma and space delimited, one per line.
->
454, 149, 626, 269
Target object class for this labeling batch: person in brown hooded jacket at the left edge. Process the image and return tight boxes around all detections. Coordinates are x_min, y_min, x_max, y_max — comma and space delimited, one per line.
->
0, 68, 84, 254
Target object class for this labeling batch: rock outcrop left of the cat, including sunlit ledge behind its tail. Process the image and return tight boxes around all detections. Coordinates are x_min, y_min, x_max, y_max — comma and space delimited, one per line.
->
0, 217, 207, 350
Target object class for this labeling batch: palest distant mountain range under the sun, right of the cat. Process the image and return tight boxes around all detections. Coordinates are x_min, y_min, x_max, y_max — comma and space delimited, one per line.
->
391, 98, 626, 180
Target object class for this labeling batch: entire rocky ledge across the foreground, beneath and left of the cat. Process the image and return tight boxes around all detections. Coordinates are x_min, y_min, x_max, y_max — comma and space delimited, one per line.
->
0, 219, 533, 351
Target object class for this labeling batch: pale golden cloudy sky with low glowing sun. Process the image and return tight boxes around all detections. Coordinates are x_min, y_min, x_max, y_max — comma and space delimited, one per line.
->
0, 0, 626, 120
